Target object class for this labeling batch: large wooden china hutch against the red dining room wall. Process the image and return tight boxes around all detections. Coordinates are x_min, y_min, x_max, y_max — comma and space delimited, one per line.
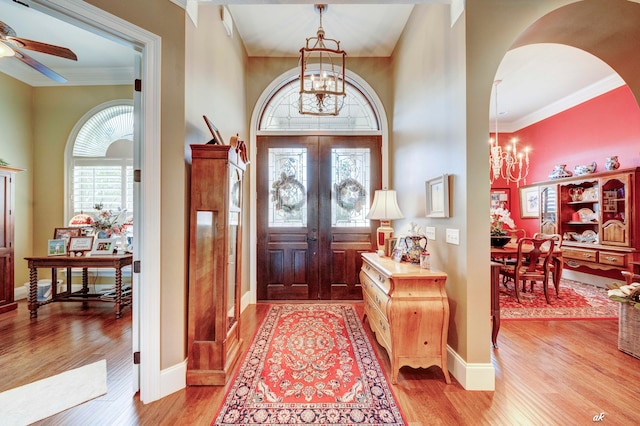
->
540, 168, 640, 271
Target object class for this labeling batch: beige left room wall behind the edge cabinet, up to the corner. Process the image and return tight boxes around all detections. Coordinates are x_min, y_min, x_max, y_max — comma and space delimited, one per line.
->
0, 73, 33, 287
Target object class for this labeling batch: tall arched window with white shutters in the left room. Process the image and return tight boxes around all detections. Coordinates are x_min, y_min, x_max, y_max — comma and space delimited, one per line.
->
67, 100, 133, 220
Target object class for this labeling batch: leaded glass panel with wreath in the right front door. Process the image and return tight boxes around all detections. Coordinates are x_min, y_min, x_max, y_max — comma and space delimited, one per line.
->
331, 148, 371, 227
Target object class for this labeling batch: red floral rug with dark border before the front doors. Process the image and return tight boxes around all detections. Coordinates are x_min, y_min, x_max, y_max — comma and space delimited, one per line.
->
212, 304, 406, 425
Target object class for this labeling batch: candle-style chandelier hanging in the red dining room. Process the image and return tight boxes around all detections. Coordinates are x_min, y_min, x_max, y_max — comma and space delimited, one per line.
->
489, 80, 529, 187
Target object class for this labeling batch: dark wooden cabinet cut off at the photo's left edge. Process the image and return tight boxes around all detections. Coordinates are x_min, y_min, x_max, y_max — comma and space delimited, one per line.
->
0, 166, 22, 313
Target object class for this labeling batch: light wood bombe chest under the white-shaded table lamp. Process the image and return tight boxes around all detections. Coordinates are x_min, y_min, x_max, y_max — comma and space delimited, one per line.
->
360, 253, 451, 383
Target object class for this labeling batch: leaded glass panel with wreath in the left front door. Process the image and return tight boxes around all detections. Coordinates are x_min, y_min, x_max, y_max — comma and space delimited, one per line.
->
269, 148, 307, 228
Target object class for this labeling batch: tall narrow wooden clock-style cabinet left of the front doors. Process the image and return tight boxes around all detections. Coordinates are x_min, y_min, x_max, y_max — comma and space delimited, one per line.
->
187, 141, 247, 385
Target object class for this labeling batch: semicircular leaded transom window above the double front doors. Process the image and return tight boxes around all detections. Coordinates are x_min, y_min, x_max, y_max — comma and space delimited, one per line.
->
258, 77, 380, 132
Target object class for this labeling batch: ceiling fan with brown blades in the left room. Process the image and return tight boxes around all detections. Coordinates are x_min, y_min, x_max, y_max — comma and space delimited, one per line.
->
0, 21, 78, 83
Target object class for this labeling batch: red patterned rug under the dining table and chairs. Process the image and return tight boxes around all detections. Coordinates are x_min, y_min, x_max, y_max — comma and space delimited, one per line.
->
500, 279, 618, 320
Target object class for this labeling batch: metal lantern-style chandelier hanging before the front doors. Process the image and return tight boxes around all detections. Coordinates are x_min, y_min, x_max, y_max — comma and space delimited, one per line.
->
299, 4, 347, 115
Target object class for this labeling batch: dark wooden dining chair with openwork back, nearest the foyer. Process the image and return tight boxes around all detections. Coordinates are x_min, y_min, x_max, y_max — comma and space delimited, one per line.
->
500, 238, 555, 303
